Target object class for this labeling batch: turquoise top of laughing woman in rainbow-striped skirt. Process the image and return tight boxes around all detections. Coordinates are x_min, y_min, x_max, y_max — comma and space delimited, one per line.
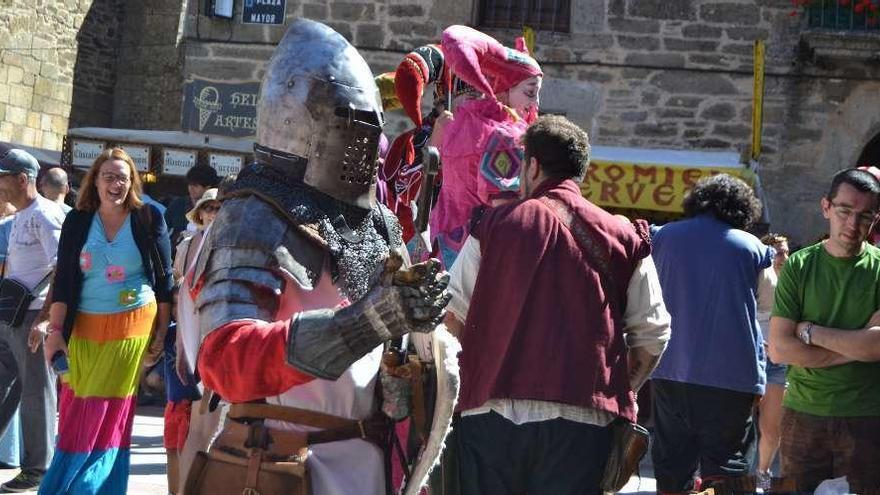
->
79, 213, 155, 314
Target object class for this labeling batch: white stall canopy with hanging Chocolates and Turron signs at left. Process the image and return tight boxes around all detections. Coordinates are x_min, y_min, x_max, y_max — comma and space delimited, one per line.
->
62, 127, 254, 176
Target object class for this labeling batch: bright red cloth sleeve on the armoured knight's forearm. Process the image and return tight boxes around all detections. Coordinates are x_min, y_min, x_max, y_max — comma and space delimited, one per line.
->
198, 320, 314, 402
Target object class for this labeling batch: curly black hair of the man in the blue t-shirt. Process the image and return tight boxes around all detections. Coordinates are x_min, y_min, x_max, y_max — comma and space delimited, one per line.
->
682, 174, 761, 230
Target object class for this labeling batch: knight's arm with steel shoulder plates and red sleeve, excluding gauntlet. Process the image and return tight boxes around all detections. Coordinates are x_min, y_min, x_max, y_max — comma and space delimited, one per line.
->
191, 197, 324, 400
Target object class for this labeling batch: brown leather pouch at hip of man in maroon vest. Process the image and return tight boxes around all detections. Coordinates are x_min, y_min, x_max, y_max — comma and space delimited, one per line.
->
602, 419, 648, 492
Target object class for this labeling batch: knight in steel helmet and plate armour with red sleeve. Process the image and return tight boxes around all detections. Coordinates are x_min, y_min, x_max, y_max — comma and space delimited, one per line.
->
187, 20, 451, 495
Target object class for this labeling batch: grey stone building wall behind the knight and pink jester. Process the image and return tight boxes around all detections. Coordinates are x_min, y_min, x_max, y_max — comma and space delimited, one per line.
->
184, 0, 880, 241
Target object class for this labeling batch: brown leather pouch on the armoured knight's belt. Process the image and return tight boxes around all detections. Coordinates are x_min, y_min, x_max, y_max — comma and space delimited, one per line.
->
184, 425, 310, 495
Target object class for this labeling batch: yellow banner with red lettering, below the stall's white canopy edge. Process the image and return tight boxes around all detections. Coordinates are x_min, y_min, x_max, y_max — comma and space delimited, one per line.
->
581, 160, 751, 212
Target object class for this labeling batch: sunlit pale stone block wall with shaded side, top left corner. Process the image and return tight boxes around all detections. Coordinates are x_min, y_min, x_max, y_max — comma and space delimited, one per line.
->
0, 0, 120, 150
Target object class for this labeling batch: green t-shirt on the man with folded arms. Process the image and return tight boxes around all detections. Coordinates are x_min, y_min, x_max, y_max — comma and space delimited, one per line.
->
773, 242, 880, 417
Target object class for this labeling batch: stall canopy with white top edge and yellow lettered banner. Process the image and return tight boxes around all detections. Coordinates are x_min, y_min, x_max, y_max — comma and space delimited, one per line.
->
581, 146, 758, 212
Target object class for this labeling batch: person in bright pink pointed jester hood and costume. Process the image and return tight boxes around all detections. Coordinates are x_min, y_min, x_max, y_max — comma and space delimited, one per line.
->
430, 26, 543, 268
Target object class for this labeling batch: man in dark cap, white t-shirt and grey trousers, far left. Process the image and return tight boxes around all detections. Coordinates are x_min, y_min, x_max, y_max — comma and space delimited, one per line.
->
0, 149, 65, 493
